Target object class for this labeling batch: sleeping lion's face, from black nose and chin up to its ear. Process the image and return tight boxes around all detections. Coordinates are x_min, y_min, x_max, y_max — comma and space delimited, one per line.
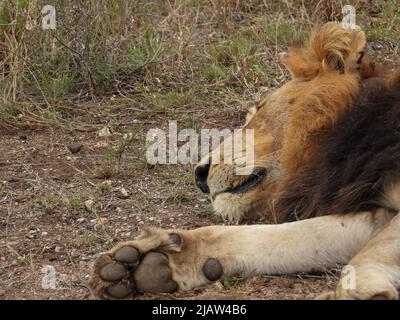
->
195, 24, 376, 222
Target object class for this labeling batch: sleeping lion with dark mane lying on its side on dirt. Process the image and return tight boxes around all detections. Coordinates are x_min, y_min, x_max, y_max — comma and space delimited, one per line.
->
90, 23, 400, 299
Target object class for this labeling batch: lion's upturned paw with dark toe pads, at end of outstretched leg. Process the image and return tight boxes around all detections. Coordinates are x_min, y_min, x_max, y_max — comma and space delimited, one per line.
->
89, 231, 181, 299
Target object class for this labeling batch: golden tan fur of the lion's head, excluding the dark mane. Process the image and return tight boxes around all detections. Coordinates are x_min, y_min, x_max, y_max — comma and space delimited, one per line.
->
200, 23, 378, 222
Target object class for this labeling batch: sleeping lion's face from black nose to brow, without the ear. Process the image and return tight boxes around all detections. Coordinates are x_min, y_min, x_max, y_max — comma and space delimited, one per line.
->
195, 81, 310, 222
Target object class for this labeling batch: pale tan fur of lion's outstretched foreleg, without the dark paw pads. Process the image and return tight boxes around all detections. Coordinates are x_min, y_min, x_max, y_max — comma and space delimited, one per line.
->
90, 211, 392, 298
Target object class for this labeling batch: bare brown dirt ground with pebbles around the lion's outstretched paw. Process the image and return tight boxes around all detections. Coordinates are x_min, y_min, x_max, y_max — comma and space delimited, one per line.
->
0, 112, 344, 299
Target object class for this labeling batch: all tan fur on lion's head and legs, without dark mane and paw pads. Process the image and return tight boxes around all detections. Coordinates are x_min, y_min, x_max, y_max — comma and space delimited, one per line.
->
90, 24, 400, 299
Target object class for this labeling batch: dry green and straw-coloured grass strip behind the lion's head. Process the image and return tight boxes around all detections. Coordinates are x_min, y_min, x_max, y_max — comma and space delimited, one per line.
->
0, 0, 400, 129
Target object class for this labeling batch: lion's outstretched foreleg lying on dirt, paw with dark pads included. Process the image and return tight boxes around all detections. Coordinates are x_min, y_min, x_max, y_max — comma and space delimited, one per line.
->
90, 212, 390, 298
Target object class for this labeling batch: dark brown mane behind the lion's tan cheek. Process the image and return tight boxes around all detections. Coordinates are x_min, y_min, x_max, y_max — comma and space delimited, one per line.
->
274, 71, 400, 221
